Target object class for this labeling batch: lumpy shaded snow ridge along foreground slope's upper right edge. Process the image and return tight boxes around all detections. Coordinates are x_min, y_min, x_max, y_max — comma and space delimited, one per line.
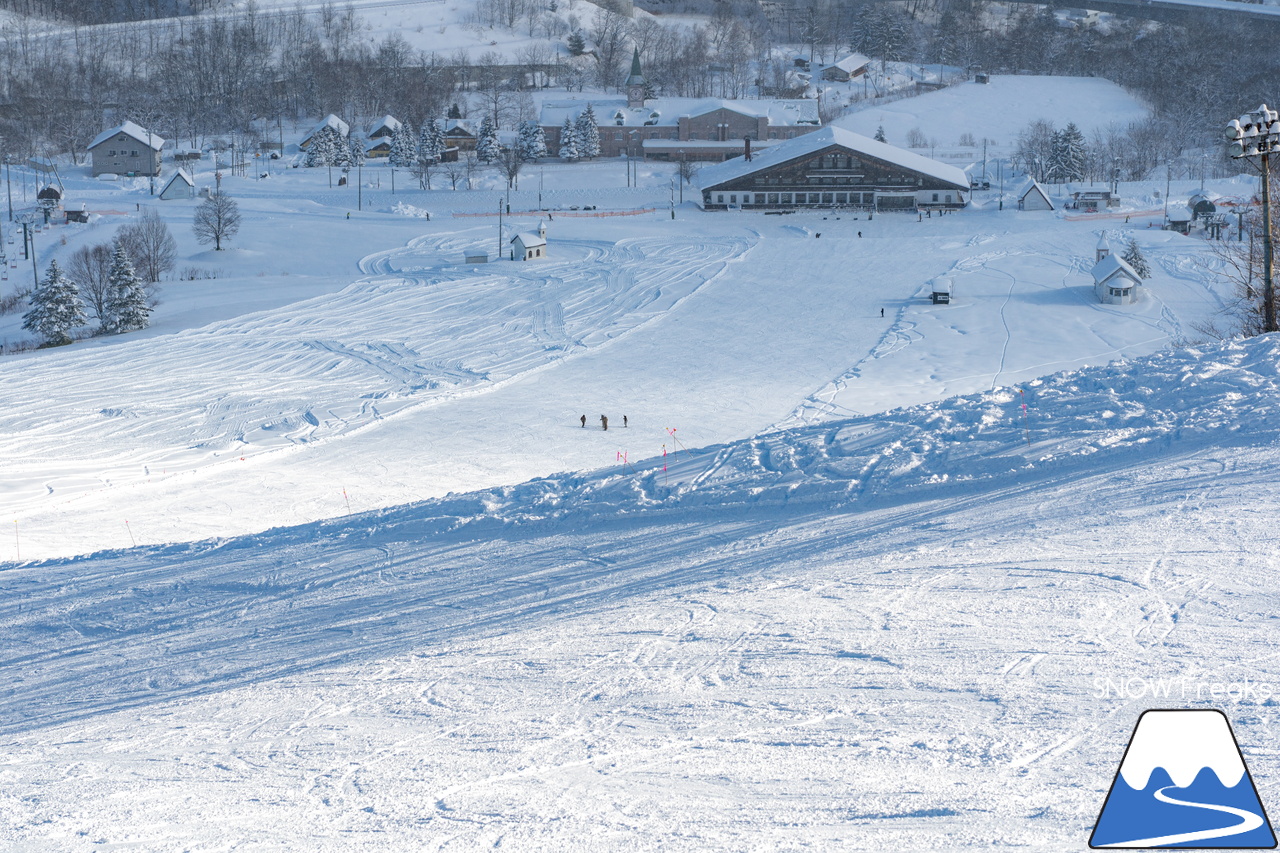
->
317, 336, 1280, 529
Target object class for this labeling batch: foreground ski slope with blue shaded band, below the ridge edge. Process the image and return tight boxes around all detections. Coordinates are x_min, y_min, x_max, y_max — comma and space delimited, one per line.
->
0, 339, 1280, 850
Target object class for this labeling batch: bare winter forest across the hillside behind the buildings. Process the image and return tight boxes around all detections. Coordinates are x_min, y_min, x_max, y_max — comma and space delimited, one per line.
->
0, 0, 1280, 174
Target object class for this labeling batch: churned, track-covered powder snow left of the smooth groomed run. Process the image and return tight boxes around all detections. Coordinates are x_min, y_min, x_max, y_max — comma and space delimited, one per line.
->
0, 229, 746, 508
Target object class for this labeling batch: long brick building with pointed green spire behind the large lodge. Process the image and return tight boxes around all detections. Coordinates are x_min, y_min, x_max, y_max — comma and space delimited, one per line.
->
538, 53, 822, 163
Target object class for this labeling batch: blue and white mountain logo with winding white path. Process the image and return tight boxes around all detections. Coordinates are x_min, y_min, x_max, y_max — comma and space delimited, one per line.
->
1089, 710, 1276, 850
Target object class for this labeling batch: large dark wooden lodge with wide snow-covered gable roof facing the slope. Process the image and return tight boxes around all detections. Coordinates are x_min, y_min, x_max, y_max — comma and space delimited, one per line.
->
698, 127, 969, 210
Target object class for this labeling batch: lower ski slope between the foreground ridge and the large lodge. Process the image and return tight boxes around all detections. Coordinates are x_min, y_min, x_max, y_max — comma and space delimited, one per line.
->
0, 200, 1222, 558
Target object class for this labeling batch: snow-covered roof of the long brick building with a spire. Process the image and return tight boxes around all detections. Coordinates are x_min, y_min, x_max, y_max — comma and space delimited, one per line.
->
538, 97, 822, 127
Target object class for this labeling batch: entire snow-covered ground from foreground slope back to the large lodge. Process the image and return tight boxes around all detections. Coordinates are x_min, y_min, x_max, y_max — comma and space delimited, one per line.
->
0, 76, 1280, 850
